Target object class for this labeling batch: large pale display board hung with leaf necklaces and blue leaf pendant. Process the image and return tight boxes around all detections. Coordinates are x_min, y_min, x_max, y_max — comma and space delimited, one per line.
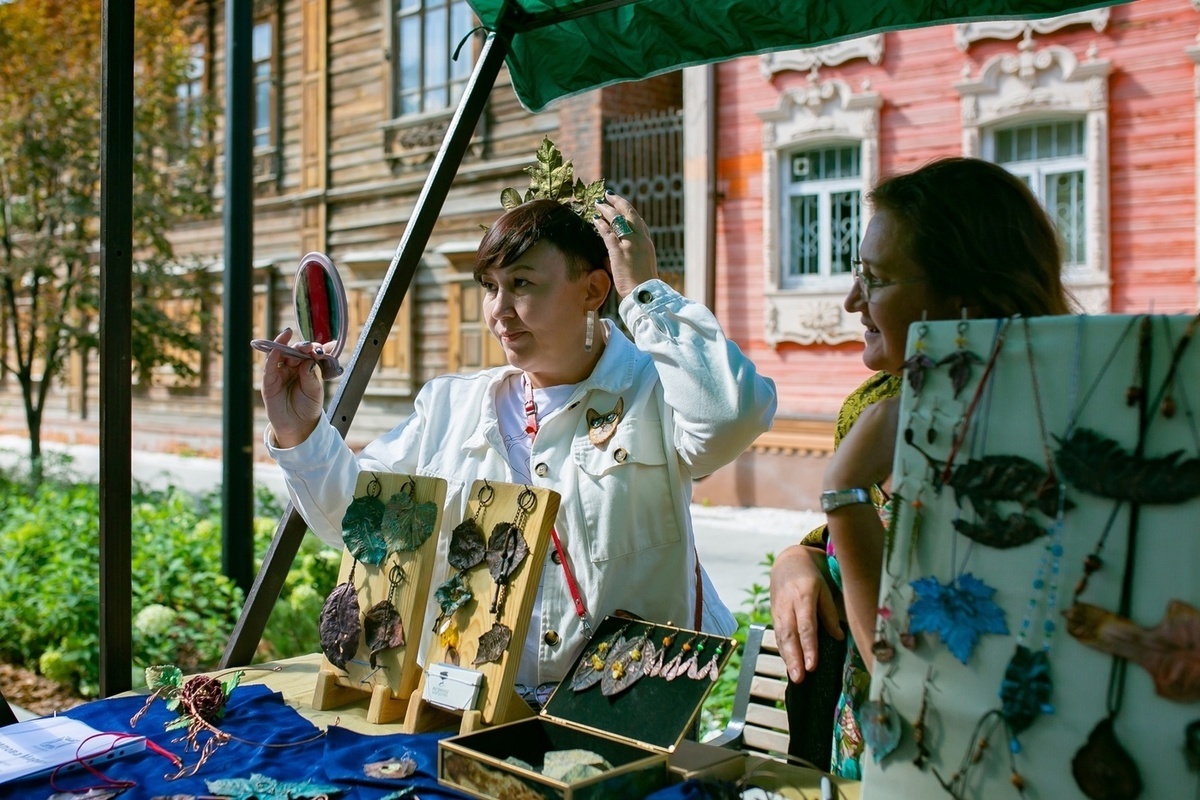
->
858, 315, 1200, 800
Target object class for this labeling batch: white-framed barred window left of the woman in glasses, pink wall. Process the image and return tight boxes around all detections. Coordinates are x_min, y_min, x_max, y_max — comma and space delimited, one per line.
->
780, 144, 863, 288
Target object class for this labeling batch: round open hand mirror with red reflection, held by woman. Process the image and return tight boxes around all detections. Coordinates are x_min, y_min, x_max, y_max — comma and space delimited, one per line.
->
250, 252, 347, 380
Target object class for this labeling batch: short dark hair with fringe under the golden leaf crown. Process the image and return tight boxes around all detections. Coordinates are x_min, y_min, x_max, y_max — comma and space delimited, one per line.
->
474, 200, 608, 279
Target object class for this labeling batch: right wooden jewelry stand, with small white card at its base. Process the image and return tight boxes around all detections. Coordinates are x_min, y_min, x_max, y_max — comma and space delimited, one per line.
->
404, 481, 559, 733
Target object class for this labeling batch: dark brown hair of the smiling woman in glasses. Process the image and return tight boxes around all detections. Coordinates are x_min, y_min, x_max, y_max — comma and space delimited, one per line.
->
866, 157, 1072, 317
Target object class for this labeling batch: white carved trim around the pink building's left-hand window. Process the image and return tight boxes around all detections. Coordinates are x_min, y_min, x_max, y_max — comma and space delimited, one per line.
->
758, 74, 883, 347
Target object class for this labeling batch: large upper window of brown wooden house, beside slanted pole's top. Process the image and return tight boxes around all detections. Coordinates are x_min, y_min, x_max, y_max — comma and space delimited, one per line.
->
392, 0, 473, 116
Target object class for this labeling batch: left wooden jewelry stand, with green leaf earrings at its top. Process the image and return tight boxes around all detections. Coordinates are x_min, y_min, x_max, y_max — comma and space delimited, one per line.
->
312, 471, 446, 724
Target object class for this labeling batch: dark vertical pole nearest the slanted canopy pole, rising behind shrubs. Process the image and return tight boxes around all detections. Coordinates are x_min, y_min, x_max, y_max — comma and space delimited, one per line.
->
221, 0, 254, 594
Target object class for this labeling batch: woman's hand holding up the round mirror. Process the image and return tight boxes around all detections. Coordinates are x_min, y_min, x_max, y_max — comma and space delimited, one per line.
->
263, 327, 332, 447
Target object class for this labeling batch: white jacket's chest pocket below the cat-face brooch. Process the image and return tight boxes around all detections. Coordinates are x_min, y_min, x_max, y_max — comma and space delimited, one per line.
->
574, 417, 683, 561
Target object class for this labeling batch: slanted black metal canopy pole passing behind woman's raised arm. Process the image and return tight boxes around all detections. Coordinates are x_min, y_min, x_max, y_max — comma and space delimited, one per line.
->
221, 28, 508, 669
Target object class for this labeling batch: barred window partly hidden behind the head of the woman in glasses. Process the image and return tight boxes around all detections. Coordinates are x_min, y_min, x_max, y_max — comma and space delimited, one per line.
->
991, 120, 1087, 266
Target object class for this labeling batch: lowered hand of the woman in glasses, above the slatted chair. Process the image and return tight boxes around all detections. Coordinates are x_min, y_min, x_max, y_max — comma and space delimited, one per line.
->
770, 545, 846, 684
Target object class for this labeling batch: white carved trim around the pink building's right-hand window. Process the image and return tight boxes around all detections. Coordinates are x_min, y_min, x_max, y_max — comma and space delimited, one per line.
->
954, 35, 1112, 313
